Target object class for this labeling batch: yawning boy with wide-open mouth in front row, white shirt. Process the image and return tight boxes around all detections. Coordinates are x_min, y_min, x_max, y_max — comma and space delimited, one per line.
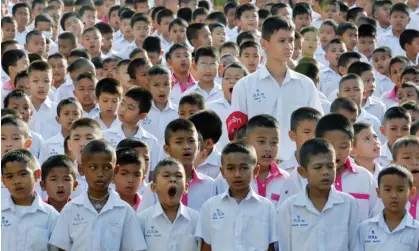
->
138, 158, 200, 251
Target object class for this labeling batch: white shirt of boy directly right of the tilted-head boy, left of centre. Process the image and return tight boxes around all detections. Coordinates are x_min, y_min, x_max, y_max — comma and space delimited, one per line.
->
141, 100, 179, 142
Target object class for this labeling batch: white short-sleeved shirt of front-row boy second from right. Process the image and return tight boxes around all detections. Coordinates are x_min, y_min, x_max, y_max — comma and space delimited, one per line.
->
278, 186, 359, 251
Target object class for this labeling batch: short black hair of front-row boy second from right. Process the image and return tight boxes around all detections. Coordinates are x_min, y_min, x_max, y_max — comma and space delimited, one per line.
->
299, 139, 336, 168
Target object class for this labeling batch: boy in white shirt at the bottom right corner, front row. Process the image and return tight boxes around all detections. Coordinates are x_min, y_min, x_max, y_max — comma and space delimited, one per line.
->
356, 165, 419, 251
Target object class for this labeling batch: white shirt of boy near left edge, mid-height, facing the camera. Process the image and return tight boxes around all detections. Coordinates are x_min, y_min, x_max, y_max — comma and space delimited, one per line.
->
29, 97, 61, 140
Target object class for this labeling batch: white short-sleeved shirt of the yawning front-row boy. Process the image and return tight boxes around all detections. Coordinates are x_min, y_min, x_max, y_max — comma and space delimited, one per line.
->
138, 203, 199, 251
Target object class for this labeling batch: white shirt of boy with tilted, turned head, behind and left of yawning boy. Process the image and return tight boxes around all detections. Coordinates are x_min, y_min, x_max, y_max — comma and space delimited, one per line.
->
103, 122, 162, 173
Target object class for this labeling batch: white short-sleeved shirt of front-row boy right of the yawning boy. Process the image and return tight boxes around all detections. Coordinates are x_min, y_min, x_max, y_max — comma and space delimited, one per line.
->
196, 189, 277, 251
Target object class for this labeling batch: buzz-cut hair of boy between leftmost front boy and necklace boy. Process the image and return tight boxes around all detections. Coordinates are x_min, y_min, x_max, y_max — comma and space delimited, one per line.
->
41, 154, 77, 182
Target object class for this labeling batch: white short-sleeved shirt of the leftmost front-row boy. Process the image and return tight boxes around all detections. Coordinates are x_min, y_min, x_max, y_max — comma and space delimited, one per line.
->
1, 195, 59, 251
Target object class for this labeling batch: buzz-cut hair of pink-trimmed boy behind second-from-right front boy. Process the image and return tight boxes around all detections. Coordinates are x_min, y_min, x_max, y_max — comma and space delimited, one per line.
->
315, 113, 354, 140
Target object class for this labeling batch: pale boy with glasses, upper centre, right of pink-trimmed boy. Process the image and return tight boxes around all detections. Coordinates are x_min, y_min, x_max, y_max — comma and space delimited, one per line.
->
182, 46, 223, 102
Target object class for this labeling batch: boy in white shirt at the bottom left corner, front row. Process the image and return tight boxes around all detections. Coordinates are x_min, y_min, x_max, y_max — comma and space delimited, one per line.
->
1, 150, 59, 250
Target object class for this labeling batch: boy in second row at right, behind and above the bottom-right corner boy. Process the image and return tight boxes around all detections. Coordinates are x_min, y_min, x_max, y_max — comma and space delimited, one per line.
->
378, 106, 412, 167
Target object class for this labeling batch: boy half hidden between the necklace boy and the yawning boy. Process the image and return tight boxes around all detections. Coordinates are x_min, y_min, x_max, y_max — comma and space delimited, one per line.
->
113, 149, 145, 212
